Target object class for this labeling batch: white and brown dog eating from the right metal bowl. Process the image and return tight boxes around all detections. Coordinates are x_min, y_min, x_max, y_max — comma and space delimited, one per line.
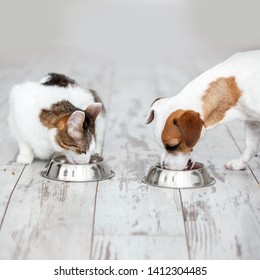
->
146, 51, 260, 170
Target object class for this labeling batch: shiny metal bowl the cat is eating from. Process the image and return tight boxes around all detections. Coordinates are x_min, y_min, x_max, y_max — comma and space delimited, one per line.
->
42, 155, 115, 182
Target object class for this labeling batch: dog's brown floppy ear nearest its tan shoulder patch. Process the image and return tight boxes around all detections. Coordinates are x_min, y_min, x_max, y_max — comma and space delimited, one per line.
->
174, 110, 203, 147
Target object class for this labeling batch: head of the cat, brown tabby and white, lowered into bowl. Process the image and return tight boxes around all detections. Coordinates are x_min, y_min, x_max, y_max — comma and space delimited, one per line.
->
40, 101, 102, 164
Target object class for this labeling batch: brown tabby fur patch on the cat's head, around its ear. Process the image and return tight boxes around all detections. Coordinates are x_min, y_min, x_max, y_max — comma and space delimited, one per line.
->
39, 101, 95, 153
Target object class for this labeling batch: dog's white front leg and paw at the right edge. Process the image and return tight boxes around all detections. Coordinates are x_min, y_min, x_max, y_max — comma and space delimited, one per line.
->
225, 121, 260, 170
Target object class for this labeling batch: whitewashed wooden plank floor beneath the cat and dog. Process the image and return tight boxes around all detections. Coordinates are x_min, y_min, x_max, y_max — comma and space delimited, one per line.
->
0, 52, 260, 259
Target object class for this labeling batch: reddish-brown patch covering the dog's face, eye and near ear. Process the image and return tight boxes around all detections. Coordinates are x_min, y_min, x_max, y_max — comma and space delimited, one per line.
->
162, 110, 203, 154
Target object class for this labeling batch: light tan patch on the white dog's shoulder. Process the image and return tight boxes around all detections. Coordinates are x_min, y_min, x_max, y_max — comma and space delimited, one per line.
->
202, 77, 242, 127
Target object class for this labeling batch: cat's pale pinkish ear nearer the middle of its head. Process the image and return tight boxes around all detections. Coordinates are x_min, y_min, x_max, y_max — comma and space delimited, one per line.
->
67, 111, 85, 139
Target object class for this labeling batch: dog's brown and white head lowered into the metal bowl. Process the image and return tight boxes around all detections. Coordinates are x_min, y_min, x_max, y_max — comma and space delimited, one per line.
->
146, 98, 203, 170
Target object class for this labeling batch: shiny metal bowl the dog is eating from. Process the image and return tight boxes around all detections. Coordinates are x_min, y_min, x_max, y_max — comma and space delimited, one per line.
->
142, 162, 216, 189
